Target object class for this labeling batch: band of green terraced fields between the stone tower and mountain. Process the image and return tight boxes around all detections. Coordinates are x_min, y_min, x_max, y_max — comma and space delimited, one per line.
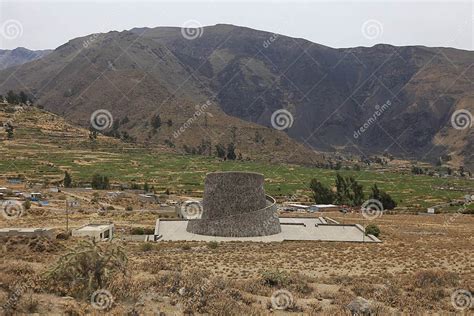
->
0, 145, 472, 209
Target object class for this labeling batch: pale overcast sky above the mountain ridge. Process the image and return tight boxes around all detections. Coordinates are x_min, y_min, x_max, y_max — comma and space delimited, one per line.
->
0, 0, 474, 50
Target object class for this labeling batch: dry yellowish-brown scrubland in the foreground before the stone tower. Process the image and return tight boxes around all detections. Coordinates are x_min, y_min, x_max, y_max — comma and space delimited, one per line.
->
0, 212, 474, 315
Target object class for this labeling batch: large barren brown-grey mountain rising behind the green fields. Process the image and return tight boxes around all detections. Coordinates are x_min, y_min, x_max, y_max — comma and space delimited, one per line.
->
0, 25, 474, 167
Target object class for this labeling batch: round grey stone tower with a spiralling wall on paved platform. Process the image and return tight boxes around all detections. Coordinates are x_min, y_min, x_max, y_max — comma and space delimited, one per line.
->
186, 172, 281, 237
